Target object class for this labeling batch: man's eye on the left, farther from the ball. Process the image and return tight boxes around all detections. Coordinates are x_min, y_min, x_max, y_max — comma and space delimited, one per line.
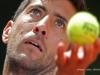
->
31, 8, 44, 21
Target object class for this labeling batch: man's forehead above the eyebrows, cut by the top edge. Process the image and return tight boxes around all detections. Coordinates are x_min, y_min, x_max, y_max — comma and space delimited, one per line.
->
31, 0, 75, 8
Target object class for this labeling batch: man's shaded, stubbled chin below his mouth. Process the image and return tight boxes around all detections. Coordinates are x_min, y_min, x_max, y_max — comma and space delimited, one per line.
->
9, 54, 43, 70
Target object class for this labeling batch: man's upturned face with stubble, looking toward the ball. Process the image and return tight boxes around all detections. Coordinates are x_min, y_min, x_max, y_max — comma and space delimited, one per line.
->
2, 0, 76, 69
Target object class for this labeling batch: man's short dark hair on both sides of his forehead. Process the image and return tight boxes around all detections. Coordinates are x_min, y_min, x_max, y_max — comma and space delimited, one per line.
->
13, 0, 86, 21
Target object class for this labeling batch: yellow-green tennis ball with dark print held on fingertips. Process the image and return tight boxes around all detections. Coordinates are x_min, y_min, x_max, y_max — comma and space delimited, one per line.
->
66, 12, 99, 45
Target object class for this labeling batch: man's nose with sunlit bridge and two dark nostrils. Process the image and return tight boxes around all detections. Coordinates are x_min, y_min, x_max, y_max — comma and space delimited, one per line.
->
33, 16, 49, 37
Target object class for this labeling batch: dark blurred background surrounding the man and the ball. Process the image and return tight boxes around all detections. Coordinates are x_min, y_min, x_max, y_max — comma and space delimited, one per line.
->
0, 0, 100, 75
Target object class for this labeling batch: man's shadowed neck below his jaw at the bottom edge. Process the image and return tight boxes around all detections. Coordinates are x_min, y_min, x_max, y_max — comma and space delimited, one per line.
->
3, 56, 56, 75
